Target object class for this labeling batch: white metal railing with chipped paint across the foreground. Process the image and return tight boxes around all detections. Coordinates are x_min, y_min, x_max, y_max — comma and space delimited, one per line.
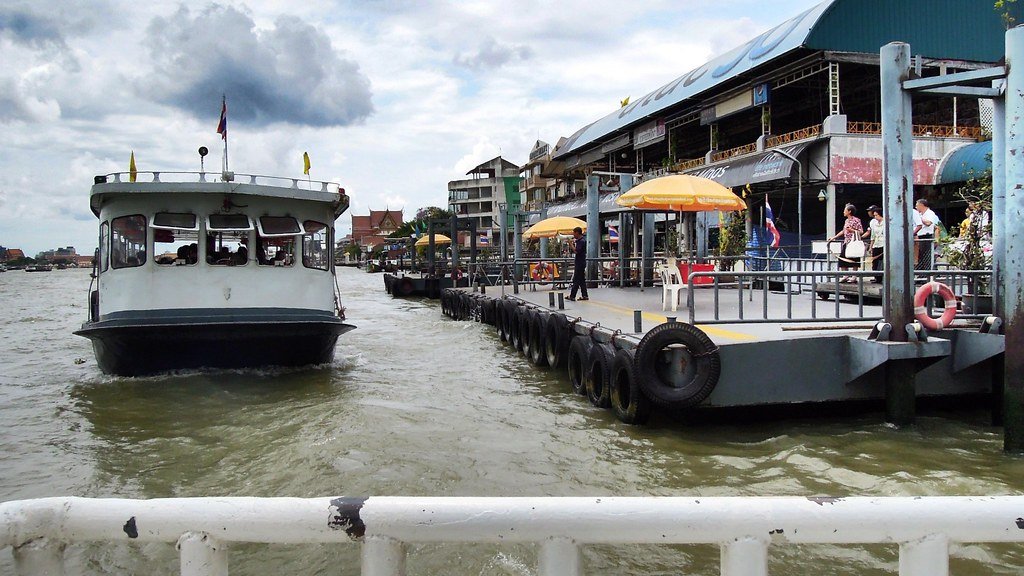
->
0, 496, 1024, 576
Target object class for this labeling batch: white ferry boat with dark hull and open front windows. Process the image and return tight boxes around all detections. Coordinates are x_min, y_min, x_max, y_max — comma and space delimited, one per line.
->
75, 168, 354, 376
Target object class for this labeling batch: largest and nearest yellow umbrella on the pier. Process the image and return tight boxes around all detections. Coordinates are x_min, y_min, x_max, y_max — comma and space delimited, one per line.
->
615, 174, 746, 212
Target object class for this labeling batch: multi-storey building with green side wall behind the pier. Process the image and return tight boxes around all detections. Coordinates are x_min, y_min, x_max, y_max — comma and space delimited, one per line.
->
447, 156, 521, 246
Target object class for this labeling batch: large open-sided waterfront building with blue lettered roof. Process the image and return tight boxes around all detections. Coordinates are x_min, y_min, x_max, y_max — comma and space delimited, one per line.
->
548, 0, 1005, 255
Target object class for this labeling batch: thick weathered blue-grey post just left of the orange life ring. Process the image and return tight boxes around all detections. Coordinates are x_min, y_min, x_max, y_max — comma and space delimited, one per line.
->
879, 42, 916, 424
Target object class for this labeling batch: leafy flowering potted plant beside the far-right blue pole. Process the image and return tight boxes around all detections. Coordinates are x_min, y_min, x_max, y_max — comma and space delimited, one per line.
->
942, 163, 992, 314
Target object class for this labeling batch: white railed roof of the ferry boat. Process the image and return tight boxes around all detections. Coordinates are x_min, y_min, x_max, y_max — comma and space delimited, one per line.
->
89, 172, 349, 218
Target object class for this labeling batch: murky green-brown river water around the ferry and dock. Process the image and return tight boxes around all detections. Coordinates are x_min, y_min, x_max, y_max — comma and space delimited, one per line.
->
0, 269, 1024, 576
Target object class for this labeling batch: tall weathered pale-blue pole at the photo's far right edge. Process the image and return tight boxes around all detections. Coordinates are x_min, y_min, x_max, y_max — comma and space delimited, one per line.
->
993, 27, 1024, 453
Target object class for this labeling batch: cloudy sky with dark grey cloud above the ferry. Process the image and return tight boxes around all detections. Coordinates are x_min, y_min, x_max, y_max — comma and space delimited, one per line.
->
0, 0, 819, 255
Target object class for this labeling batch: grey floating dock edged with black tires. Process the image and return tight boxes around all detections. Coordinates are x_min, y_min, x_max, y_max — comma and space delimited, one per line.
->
441, 284, 1004, 423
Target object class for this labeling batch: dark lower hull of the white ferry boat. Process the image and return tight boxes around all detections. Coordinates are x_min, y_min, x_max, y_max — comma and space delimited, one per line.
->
75, 308, 354, 376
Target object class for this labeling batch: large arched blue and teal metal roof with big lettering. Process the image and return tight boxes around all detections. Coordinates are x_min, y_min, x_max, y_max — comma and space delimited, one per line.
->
554, 0, 1003, 164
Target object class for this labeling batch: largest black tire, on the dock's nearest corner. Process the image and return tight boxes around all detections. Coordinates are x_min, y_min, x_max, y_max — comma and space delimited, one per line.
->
634, 322, 722, 409
